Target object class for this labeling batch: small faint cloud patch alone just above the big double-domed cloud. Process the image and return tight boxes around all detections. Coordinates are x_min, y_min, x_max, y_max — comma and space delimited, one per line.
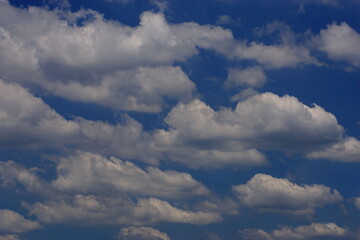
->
224, 67, 266, 88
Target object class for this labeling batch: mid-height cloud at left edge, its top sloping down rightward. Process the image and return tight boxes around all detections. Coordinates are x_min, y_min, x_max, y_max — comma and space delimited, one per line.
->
0, 80, 79, 148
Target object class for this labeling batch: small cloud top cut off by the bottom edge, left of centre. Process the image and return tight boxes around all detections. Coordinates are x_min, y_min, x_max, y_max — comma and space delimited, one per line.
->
117, 227, 170, 240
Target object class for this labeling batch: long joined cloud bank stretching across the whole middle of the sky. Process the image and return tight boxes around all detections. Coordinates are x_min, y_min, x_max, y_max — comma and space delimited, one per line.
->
0, 81, 359, 167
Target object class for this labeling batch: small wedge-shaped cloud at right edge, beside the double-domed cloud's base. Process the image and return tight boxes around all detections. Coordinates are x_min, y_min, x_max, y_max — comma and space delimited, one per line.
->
307, 137, 360, 162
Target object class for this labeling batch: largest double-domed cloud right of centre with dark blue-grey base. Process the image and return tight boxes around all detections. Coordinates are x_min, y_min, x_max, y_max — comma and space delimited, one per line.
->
150, 93, 356, 167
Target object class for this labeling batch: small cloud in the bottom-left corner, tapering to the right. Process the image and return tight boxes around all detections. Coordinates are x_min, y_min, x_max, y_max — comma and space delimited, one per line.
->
0, 209, 41, 233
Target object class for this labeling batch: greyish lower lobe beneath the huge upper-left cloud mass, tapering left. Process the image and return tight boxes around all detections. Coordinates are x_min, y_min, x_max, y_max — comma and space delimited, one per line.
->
46, 67, 195, 112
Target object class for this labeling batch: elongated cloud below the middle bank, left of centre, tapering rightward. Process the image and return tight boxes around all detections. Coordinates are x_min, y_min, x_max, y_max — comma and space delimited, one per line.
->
52, 152, 209, 198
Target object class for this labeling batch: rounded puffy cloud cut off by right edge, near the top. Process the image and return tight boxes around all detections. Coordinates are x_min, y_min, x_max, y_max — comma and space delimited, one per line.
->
314, 22, 360, 67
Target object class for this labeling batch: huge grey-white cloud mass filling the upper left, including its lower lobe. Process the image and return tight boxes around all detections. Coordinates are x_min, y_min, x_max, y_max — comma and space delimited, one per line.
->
0, 2, 232, 112
